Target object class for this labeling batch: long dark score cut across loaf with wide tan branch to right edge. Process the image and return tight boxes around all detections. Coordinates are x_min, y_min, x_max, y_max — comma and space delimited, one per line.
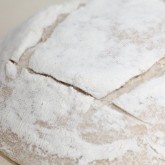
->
10, 53, 165, 122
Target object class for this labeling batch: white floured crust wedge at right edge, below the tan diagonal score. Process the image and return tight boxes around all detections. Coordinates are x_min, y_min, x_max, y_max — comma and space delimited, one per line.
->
114, 74, 165, 157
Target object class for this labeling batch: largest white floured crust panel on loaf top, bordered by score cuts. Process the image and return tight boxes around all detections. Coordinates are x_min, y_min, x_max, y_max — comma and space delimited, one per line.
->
29, 0, 165, 98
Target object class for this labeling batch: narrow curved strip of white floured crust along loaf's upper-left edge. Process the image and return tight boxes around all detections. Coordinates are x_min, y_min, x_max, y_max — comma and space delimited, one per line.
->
7, 0, 87, 62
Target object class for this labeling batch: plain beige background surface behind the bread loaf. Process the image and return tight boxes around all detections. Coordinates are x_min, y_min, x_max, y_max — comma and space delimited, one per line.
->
0, 0, 64, 165
